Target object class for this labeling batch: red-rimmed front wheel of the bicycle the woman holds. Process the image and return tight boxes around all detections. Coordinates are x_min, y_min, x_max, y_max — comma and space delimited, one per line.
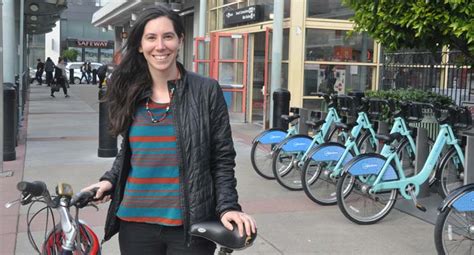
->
42, 223, 101, 255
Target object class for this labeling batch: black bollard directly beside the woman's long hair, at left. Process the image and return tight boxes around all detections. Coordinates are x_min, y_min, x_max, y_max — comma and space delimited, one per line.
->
97, 88, 118, 158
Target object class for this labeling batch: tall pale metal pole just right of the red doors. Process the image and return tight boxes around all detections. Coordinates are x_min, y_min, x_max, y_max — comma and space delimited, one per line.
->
270, 0, 284, 127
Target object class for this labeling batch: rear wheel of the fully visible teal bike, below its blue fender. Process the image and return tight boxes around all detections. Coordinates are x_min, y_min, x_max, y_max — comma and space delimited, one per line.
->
336, 172, 398, 225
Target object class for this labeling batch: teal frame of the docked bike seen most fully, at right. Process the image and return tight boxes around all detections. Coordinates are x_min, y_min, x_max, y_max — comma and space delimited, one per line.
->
369, 124, 464, 199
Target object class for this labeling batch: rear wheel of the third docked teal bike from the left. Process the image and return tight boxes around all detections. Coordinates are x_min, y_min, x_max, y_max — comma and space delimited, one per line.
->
301, 143, 353, 205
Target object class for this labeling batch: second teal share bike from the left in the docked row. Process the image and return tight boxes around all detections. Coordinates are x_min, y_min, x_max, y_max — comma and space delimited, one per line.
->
272, 92, 376, 190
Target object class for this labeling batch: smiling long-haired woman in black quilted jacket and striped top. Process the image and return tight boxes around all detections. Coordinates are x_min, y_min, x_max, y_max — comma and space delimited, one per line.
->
83, 5, 256, 255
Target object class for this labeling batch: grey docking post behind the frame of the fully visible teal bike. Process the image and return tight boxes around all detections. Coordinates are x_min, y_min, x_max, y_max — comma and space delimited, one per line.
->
414, 127, 430, 198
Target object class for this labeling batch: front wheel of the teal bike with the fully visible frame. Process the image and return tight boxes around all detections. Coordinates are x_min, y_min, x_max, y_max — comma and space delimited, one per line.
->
438, 148, 464, 198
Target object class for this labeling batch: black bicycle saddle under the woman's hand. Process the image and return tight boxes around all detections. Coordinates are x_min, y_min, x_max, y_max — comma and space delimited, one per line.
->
189, 221, 257, 250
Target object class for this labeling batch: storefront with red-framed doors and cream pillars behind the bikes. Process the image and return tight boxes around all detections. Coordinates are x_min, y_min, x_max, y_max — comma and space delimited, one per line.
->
200, 0, 379, 127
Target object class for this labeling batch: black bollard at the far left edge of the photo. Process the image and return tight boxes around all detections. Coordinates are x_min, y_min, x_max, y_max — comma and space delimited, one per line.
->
3, 83, 17, 161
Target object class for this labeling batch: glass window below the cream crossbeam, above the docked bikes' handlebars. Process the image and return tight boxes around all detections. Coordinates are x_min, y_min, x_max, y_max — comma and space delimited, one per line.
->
303, 64, 374, 96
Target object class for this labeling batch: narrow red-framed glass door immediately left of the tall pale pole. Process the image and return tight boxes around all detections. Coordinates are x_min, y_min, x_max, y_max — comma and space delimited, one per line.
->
250, 28, 271, 129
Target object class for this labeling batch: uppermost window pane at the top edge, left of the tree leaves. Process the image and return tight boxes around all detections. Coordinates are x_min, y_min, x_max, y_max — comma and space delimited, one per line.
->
307, 0, 354, 20
